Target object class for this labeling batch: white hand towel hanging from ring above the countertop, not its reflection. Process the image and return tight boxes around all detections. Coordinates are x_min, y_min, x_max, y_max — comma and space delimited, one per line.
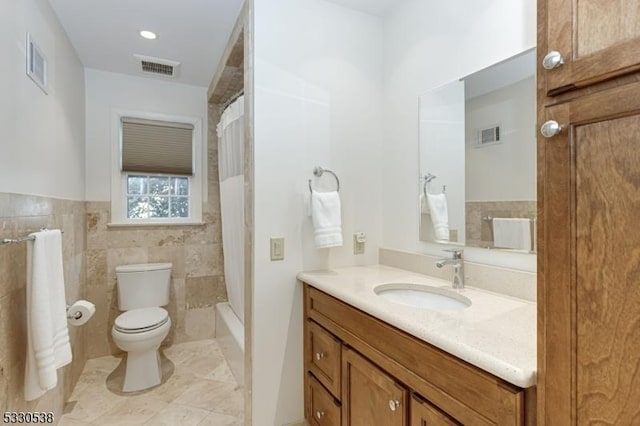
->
311, 191, 342, 248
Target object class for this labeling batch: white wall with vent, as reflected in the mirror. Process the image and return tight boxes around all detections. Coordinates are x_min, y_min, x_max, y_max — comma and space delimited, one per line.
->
465, 77, 537, 201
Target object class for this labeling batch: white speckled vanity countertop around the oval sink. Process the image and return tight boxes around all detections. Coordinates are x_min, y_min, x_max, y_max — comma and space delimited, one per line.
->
298, 265, 536, 388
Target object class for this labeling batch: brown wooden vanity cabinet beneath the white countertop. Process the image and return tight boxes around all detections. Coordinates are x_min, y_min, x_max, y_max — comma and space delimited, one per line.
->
304, 284, 535, 426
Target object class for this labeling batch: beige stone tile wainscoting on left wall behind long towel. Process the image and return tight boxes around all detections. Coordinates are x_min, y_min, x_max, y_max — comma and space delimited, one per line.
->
0, 193, 87, 419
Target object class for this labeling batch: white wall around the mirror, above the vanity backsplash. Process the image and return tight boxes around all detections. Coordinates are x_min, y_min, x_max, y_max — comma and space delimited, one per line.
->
381, 0, 536, 270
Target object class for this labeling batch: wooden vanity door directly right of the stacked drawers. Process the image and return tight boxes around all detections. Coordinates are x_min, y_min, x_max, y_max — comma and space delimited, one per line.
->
342, 347, 408, 426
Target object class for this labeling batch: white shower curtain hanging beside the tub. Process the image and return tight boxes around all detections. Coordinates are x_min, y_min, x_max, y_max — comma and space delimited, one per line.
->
218, 96, 244, 324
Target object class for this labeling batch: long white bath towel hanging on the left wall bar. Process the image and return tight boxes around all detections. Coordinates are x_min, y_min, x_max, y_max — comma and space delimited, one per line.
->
24, 230, 71, 401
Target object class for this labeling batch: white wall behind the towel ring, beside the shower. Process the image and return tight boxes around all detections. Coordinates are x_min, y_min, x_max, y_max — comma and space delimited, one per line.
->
252, 0, 382, 425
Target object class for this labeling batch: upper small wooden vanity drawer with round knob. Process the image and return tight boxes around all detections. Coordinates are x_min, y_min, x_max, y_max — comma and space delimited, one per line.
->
305, 320, 341, 400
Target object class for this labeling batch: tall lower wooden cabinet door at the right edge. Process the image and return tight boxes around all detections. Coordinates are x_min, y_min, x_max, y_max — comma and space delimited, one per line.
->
538, 82, 640, 425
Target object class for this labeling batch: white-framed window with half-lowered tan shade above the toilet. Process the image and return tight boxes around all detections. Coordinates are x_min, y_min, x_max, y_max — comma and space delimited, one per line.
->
111, 114, 204, 225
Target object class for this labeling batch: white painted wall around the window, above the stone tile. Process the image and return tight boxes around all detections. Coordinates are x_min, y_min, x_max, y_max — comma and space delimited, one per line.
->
85, 68, 207, 201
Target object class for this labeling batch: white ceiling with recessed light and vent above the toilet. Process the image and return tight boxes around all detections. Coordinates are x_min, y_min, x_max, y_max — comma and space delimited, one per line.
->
49, 0, 242, 87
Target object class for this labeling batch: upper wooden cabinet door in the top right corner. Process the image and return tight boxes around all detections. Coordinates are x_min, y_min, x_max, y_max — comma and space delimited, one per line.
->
538, 0, 640, 94
